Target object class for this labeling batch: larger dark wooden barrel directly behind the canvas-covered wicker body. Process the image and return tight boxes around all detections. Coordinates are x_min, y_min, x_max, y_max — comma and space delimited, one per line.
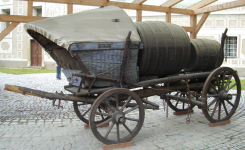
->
135, 21, 190, 76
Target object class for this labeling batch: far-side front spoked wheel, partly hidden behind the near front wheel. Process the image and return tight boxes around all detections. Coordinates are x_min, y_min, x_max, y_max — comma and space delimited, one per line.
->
73, 101, 108, 124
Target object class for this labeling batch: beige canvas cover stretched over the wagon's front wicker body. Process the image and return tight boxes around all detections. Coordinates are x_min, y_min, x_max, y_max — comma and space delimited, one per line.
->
25, 6, 141, 49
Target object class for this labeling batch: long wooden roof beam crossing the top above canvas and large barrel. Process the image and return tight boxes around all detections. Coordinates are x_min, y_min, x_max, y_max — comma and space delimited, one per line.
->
20, 0, 194, 15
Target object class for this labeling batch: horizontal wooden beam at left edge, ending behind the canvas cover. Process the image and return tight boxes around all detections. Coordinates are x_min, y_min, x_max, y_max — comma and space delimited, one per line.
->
0, 14, 48, 23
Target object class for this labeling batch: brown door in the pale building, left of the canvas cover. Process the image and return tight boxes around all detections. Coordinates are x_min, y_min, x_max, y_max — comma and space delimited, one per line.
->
31, 40, 42, 66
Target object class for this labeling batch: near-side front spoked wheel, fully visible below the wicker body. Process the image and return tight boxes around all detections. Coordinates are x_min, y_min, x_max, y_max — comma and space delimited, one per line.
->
89, 88, 145, 144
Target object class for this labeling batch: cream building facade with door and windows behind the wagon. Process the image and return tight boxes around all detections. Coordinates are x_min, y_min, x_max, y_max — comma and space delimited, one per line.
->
0, 0, 245, 76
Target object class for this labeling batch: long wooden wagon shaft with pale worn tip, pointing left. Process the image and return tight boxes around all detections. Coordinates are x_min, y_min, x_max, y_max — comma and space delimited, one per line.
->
4, 84, 97, 103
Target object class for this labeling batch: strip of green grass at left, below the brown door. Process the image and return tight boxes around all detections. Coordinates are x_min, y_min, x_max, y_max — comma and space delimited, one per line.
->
0, 68, 56, 74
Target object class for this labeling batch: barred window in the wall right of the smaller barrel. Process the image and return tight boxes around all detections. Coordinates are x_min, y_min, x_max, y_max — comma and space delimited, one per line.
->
224, 36, 237, 57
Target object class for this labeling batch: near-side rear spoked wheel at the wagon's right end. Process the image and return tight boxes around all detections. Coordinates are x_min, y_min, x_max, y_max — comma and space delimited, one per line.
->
202, 67, 241, 123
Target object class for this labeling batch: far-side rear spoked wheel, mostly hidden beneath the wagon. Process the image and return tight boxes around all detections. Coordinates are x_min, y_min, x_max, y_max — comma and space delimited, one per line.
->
167, 92, 195, 112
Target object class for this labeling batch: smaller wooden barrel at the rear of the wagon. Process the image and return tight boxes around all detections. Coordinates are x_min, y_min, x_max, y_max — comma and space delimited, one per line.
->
185, 39, 224, 71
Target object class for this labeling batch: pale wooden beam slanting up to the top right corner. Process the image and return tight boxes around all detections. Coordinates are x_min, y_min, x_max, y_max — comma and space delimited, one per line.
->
194, 0, 245, 14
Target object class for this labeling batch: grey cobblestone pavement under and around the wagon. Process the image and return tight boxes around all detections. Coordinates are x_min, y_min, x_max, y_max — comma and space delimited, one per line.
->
0, 73, 245, 150
